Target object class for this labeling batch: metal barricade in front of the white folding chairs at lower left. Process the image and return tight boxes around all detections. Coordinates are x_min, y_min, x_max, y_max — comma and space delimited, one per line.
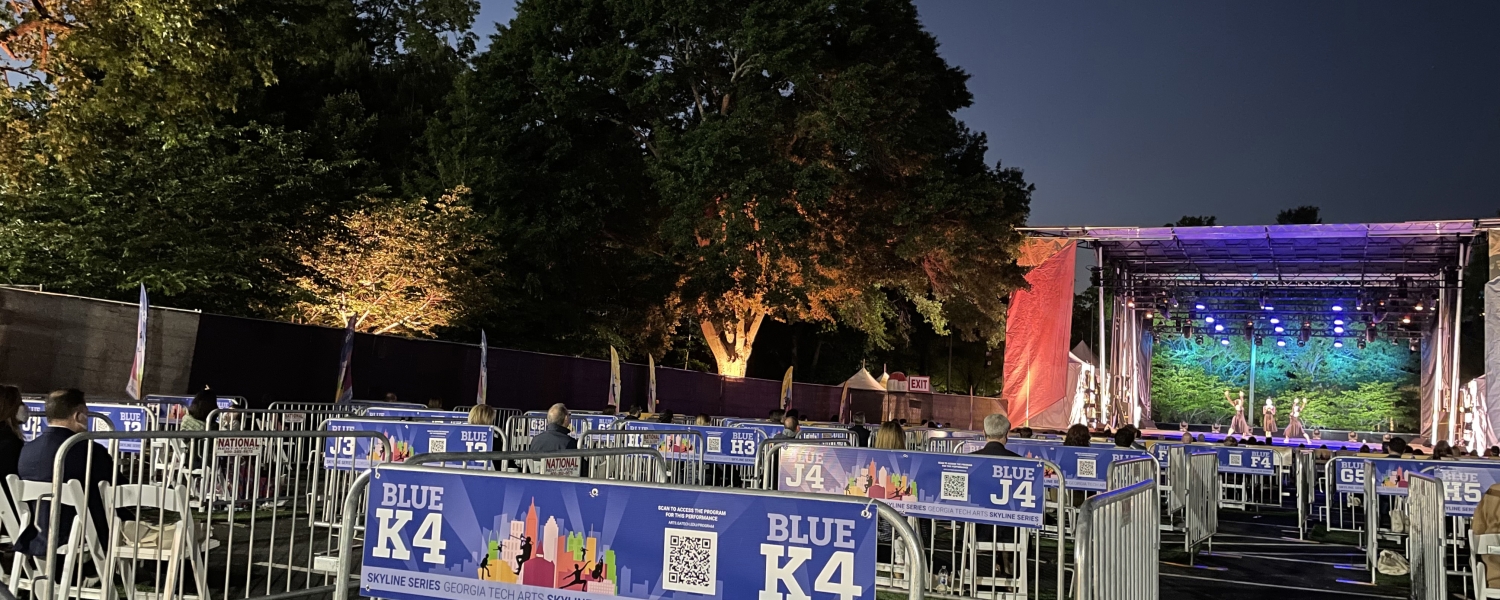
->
29, 431, 384, 600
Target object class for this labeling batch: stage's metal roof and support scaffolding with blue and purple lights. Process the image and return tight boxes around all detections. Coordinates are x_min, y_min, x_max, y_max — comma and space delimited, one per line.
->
1023, 221, 1500, 441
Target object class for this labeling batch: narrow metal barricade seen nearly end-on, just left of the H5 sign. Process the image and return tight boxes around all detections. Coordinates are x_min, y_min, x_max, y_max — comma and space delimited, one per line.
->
1407, 473, 1448, 600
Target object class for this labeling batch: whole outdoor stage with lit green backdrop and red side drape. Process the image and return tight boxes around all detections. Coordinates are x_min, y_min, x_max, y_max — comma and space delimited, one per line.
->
1004, 221, 1482, 449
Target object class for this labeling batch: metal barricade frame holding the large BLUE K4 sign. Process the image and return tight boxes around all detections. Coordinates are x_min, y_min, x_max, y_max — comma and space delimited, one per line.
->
335, 468, 929, 600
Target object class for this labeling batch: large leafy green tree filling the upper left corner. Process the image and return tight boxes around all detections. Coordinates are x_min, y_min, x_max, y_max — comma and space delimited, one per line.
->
0, 0, 477, 317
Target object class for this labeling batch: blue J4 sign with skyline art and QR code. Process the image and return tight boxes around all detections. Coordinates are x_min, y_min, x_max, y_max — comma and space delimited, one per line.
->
777, 446, 1046, 528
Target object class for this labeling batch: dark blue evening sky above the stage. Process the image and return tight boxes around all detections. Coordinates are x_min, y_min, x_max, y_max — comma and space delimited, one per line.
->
476, 0, 1500, 225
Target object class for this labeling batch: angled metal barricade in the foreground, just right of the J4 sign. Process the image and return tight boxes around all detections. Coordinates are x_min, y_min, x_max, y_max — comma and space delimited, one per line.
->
1080, 477, 1161, 600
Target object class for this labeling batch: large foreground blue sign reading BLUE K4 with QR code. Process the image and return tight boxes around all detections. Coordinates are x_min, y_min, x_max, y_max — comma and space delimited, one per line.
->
359, 467, 876, 600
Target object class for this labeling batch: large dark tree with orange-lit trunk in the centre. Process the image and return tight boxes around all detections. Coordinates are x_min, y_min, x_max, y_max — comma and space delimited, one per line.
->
431, 0, 1031, 375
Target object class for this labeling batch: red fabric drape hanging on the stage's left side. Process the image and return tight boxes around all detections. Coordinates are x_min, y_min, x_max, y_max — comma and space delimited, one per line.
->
1001, 239, 1077, 429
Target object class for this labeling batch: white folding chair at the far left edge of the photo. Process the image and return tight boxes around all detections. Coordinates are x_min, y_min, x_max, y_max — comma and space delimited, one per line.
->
6, 476, 114, 600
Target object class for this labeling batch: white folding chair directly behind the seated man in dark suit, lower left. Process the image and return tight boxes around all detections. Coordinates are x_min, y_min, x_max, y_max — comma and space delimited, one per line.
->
99, 483, 218, 600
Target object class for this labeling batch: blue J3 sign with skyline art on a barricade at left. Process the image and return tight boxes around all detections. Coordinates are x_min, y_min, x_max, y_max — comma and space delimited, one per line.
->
323, 419, 495, 471
